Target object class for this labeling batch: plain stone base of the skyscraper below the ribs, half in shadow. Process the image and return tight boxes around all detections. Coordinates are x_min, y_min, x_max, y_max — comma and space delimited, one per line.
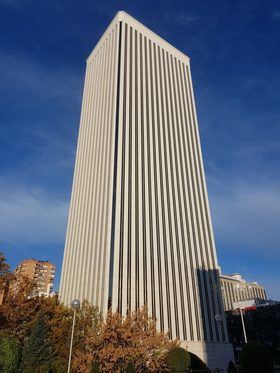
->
180, 341, 234, 369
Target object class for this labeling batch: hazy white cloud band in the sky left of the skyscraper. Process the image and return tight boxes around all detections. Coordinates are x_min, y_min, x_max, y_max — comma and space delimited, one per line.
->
0, 183, 68, 245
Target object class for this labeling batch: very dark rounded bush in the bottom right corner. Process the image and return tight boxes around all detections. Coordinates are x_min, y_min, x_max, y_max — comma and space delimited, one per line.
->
240, 342, 273, 373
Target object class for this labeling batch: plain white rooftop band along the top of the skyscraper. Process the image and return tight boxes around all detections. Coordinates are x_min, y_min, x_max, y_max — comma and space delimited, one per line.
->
86, 10, 190, 65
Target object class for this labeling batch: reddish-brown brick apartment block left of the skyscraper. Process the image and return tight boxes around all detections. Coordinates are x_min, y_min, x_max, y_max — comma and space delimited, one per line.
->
14, 259, 55, 296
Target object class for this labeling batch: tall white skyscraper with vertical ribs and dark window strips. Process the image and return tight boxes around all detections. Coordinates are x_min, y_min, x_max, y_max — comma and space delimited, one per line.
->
60, 12, 234, 367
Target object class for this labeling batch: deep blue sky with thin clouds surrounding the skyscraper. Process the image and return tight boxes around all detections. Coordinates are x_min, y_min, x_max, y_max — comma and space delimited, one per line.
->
0, 0, 280, 299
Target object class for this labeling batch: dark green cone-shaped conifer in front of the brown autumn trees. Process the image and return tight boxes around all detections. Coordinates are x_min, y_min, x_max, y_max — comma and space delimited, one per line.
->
20, 312, 53, 373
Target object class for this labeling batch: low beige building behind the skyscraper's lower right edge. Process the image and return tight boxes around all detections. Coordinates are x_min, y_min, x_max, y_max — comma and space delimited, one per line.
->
220, 273, 267, 311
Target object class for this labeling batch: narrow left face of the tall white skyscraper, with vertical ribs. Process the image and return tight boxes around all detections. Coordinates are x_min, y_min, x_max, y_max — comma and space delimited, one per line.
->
60, 18, 119, 310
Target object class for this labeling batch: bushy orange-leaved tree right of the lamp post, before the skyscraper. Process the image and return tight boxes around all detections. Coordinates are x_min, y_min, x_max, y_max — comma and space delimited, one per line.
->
73, 308, 178, 373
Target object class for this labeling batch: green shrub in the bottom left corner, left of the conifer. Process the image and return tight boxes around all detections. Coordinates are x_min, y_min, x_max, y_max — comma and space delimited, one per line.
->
0, 336, 21, 373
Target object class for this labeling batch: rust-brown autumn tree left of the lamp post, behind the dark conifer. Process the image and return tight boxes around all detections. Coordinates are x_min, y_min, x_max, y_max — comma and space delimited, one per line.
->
0, 251, 74, 373
